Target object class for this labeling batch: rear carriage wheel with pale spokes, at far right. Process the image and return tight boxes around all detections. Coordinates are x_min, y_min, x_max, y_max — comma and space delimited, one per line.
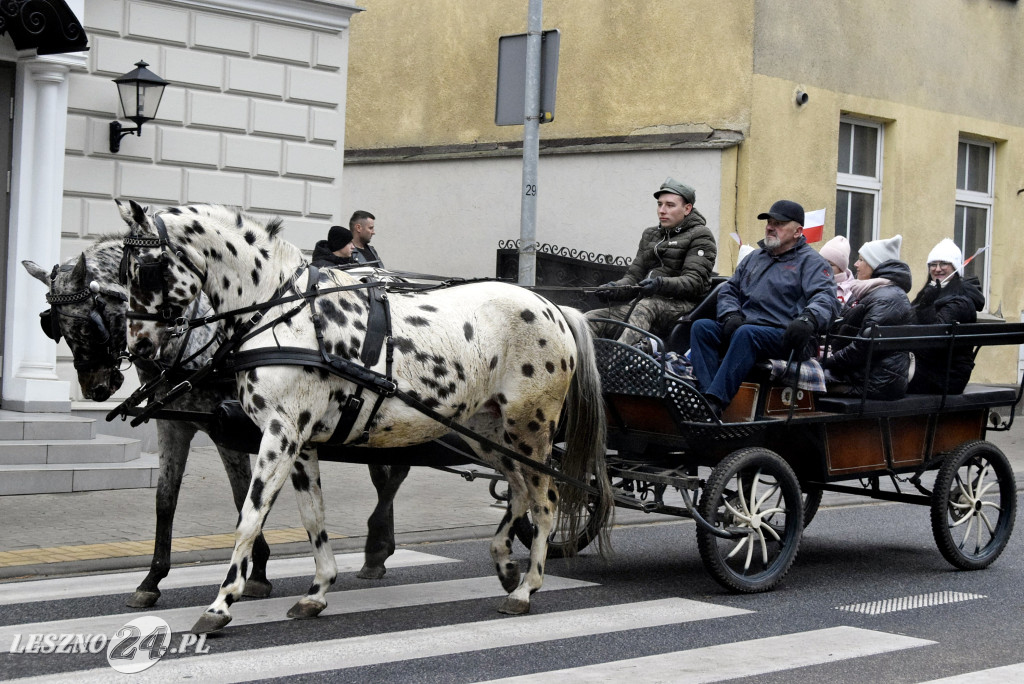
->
932, 441, 1017, 570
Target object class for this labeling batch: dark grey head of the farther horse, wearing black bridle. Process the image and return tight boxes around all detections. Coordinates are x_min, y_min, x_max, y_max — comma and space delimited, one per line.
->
22, 253, 127, 401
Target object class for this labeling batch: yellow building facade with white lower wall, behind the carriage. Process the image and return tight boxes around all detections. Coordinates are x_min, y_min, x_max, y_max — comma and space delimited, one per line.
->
342, 0, 1024, 382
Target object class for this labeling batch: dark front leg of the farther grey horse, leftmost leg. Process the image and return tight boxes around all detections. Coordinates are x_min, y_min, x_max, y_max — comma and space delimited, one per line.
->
126, 421, 196, 608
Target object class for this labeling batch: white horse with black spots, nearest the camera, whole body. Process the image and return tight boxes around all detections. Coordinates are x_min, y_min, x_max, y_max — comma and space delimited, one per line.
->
123, 202, 611, 633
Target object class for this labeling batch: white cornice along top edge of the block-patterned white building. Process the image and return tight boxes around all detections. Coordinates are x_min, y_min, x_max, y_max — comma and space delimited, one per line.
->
162, 0, 364, 33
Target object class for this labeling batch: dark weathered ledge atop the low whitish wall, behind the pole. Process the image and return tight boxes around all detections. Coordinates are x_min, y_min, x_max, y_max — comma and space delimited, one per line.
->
345, 130, 743, 164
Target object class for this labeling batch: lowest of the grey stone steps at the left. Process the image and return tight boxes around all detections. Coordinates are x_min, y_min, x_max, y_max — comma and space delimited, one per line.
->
0, 454, 160, 493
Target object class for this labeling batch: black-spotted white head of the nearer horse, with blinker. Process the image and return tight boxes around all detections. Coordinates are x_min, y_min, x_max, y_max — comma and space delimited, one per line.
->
117, 201, 206, 359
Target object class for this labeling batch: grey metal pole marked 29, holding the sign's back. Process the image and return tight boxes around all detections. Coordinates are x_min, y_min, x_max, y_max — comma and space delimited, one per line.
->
519, 0, 544, 287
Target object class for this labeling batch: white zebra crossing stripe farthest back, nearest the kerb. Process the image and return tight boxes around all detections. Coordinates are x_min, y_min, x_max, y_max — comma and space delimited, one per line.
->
0, 549, 460, 605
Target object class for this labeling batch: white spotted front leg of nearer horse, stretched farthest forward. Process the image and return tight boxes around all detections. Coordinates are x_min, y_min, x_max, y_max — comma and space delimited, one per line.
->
191, 428, 304, 634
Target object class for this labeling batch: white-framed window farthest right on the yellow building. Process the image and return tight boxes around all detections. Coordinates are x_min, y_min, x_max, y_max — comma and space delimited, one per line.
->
953, 139, 995, 301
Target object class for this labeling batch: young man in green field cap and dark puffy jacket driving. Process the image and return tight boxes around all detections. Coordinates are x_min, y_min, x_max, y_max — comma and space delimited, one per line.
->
587, 178, 718, 344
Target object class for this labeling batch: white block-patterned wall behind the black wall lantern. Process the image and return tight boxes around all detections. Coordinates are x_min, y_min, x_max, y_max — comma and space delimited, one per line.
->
55, 0, 360, 401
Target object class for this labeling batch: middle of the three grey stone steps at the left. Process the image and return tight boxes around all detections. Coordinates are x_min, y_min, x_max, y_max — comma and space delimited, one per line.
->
0, 434, 141, 466
